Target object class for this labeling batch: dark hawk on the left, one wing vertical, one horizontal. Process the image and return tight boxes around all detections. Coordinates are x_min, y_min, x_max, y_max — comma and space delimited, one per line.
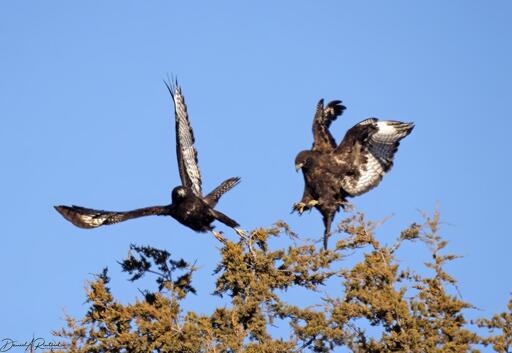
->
55, 81, 243, 240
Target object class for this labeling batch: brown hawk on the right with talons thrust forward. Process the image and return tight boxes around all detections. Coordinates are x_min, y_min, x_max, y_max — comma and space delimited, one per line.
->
293, 99, 414, 249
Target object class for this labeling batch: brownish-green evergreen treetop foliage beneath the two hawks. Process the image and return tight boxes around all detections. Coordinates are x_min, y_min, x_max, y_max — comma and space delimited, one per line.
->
51, 213, 512, 353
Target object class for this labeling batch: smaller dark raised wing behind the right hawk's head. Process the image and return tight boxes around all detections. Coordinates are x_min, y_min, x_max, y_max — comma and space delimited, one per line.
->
313, 99, 346, 152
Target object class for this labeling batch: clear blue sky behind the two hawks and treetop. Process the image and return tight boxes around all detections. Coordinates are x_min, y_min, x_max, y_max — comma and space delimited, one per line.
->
0, 1, 512, 346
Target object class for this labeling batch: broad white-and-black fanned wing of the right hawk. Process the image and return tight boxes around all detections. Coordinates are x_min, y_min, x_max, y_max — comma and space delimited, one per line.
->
334, 118, 414, 196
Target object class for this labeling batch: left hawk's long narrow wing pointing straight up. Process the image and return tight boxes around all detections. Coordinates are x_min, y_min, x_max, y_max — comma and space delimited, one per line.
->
164, 81, 202, 197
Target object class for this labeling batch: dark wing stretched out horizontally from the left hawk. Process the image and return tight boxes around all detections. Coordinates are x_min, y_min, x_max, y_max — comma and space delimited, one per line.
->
54, 205, 171, 228
